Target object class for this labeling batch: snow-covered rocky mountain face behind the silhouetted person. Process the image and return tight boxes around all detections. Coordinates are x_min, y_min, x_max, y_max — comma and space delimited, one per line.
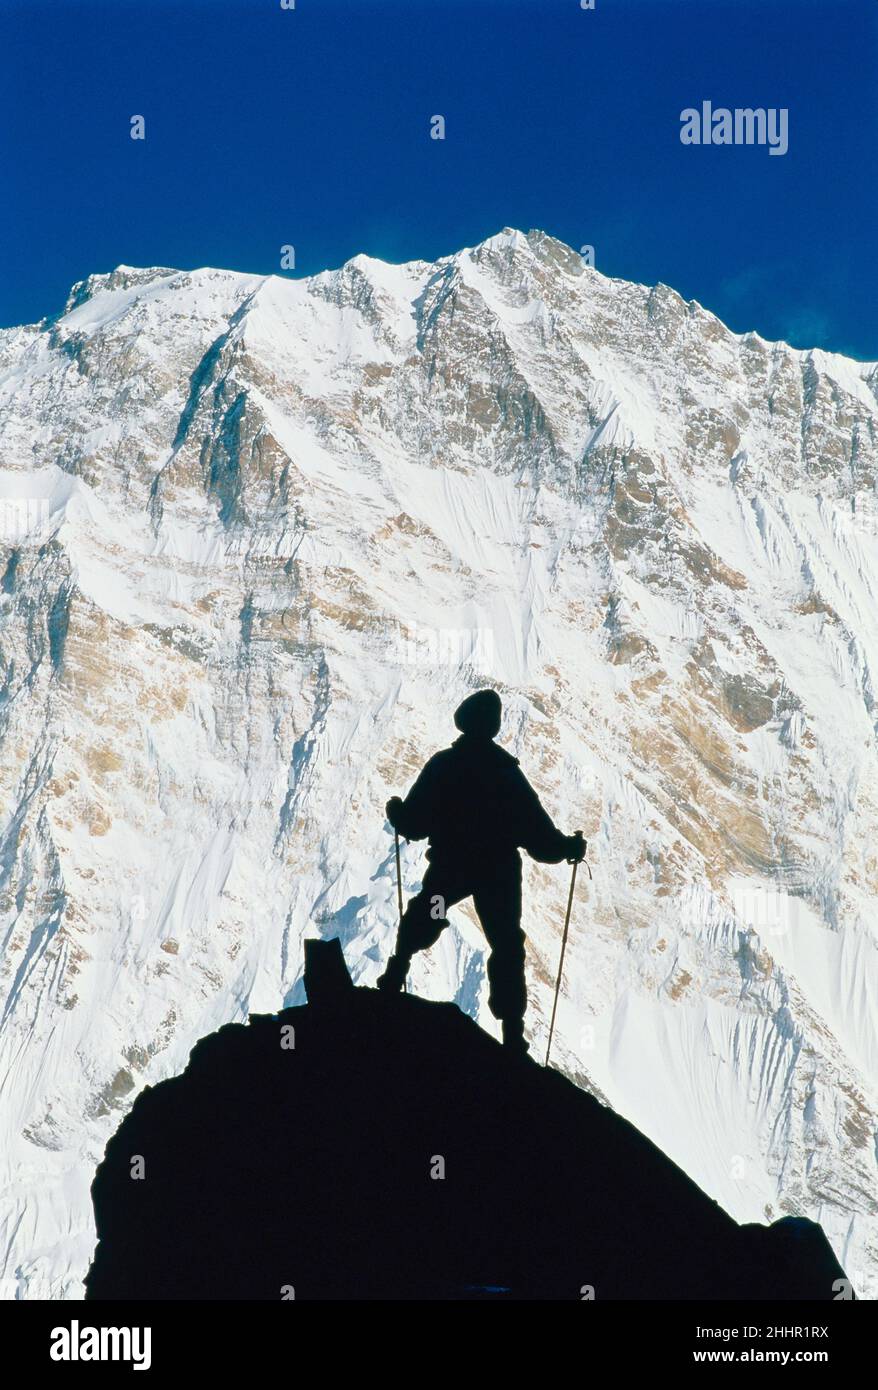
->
0, 231, 878, 1297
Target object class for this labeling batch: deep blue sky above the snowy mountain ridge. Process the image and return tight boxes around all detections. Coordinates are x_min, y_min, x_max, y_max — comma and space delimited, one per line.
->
0, 0, 878, 360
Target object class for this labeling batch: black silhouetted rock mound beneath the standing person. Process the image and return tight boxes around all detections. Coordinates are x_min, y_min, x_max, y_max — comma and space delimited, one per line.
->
86, 942, 845, 1300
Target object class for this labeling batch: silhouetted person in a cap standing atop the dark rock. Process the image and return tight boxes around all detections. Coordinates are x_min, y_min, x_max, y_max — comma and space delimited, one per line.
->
378, 691, 585, 1052
